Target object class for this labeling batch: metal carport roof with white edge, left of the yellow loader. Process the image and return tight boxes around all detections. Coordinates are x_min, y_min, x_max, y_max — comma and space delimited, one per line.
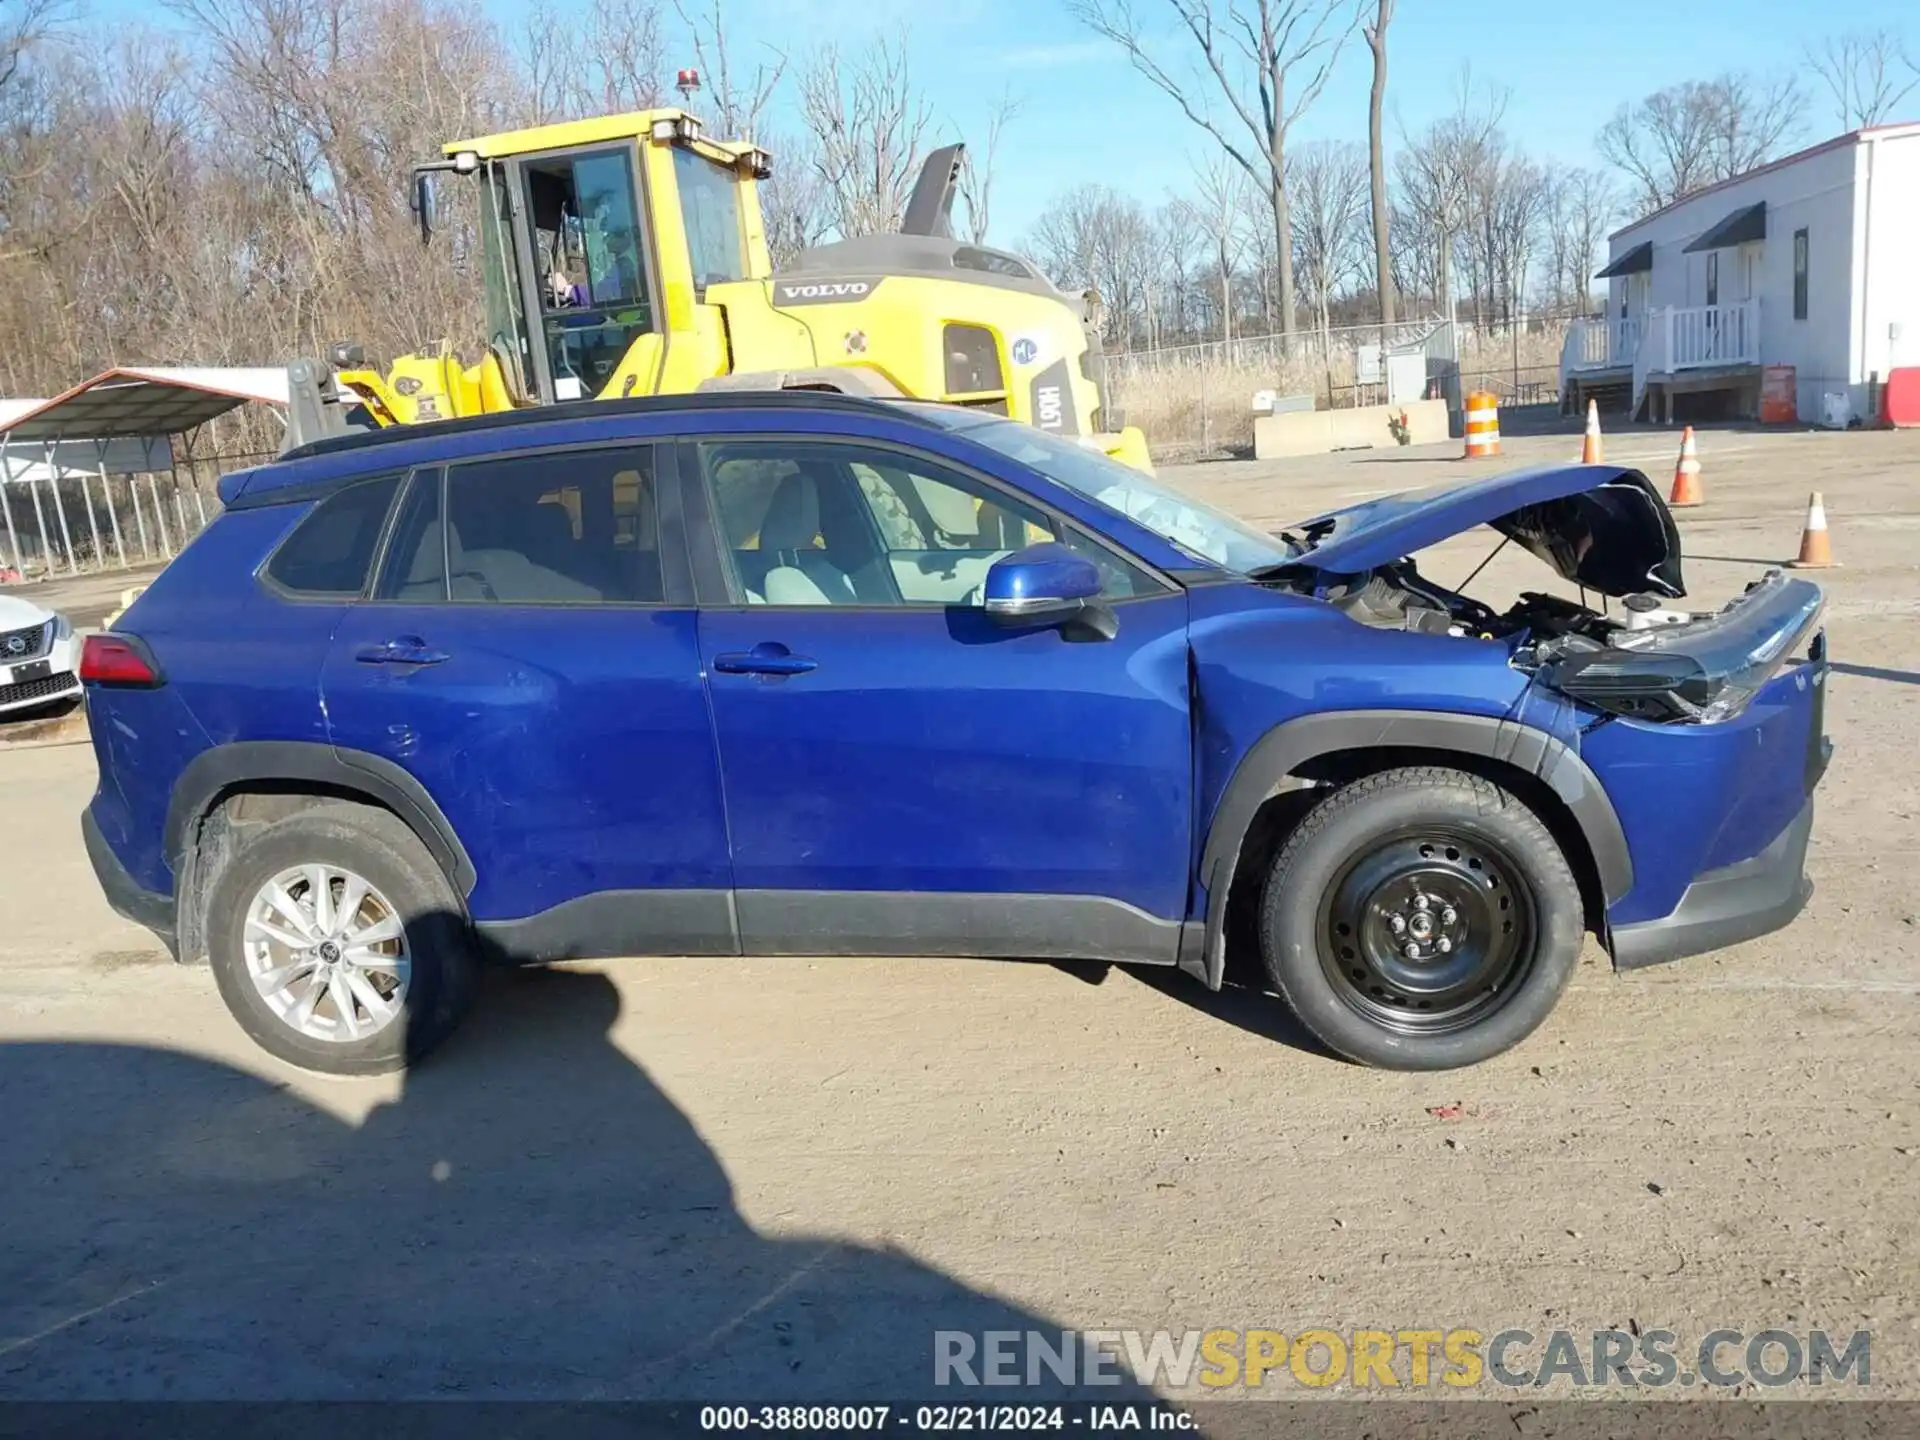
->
0, 365, 286, 444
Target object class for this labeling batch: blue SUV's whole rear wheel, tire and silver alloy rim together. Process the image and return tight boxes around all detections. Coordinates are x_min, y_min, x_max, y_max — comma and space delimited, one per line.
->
207, 801, 472, 1075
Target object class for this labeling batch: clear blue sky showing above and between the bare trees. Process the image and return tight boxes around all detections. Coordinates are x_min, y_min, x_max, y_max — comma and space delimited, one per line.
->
94, 0, 1920, 244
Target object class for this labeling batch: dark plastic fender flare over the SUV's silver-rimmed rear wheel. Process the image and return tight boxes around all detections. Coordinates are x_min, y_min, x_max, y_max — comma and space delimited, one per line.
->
163, 739, 476, 895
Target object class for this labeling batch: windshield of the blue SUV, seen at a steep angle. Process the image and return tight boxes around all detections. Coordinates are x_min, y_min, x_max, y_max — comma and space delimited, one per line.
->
924, 407, 1294, 574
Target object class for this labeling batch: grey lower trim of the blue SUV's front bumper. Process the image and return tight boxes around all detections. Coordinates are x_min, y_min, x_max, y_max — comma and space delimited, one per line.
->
1613, 795, 1812, 970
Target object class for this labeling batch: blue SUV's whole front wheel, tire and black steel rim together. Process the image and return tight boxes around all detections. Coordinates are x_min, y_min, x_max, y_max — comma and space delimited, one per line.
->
1260, 766, 1586, 1069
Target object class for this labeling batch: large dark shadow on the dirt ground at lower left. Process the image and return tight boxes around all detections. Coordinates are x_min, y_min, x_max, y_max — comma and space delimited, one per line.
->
0, 972, 1144, 1402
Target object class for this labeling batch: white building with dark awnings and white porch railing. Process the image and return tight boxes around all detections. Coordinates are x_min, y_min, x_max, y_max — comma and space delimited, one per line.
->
1561, 123, 1920, 422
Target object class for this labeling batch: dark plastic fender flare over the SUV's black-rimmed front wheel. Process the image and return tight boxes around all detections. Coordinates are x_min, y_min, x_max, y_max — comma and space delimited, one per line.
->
1187, 710, 1634, 991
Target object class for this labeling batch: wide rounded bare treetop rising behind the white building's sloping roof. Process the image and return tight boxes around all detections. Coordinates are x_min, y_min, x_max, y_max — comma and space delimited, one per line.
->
1594, 73, 1807, 211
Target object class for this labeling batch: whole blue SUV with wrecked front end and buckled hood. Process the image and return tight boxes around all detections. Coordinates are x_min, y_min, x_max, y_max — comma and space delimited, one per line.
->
83, 392, 1828, 1073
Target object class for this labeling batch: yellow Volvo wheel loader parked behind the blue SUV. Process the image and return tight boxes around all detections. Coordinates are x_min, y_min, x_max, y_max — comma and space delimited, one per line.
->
288, 109, 1152, 468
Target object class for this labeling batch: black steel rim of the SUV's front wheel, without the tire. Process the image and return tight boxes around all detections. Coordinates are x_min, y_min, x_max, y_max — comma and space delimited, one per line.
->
1319, 829, 1536, 1035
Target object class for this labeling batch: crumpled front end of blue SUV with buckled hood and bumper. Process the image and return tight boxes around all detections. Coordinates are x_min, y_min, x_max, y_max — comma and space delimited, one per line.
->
1258, 465, 1832, 990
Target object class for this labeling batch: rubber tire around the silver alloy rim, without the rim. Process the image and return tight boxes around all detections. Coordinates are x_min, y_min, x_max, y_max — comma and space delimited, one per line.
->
207, 801, 474, 1075
